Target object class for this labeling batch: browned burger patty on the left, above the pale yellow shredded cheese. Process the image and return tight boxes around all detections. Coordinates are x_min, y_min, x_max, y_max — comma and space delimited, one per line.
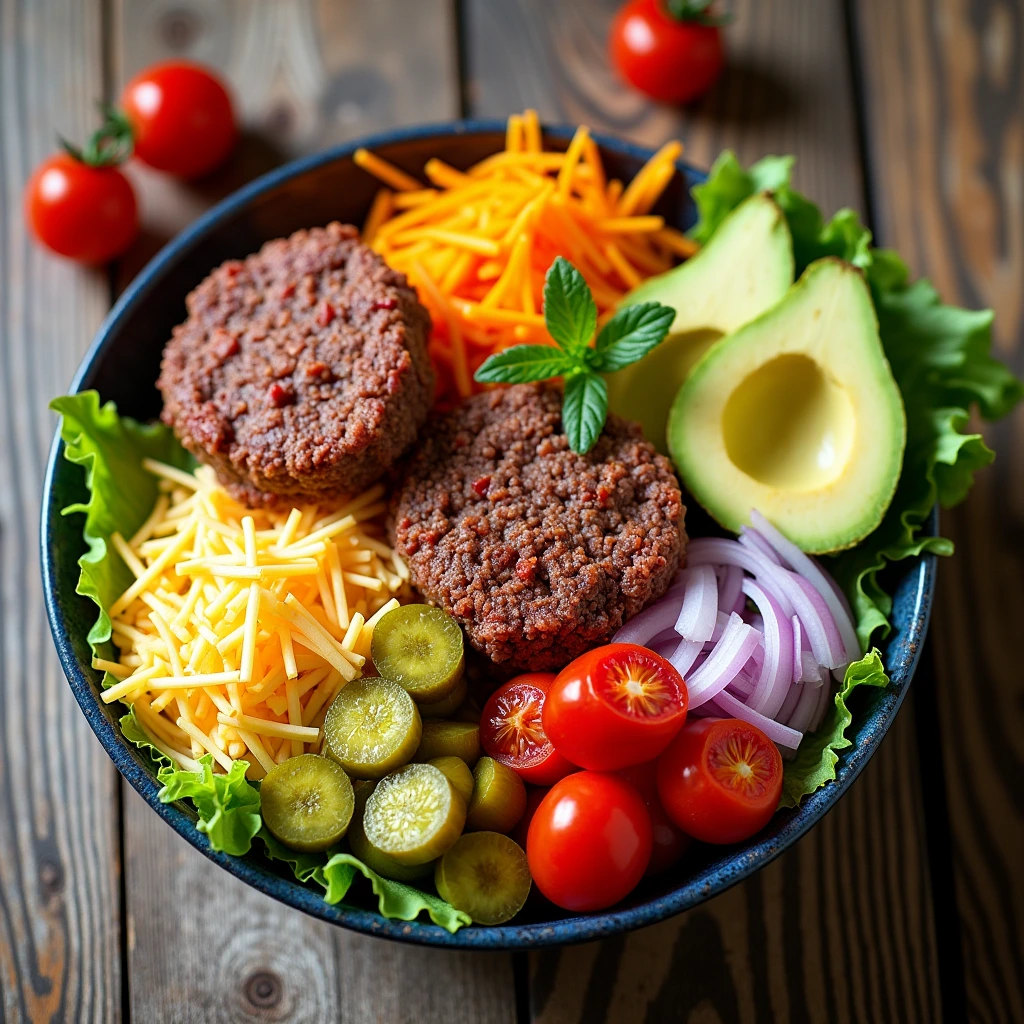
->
158, 224, 434, 505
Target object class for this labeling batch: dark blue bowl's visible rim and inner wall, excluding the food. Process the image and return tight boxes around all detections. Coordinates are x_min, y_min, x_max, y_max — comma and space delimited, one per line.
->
42, 122, 937, 948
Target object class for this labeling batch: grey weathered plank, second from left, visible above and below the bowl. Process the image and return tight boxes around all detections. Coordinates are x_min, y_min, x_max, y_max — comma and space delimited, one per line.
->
114, 0, 515, 1024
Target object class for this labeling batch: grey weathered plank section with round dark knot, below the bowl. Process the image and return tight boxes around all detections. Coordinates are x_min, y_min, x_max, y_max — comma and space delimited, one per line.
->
125, 791, 515, 1024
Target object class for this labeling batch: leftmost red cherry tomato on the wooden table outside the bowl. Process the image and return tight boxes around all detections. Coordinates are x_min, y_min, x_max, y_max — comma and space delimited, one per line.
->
25, 153, 138, 263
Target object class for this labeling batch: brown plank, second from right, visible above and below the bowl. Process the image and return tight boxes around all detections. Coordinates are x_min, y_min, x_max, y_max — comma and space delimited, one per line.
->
467, 0, 941, 1024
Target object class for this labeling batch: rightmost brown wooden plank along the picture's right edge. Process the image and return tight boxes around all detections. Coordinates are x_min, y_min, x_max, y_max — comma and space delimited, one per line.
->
856, 0, 1024, 1022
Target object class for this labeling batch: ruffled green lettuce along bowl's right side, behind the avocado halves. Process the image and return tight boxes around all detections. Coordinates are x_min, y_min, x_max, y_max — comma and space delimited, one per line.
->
690, 151, 1024, 806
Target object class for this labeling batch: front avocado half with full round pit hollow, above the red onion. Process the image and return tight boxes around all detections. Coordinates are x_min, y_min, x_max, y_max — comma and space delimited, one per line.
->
668, 258, 906, 553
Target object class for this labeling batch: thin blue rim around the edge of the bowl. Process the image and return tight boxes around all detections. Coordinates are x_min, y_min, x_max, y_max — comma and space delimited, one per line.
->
40, 120, 938, 950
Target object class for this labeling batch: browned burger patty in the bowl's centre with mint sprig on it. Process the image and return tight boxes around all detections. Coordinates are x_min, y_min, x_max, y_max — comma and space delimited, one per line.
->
393, 384, 686, 670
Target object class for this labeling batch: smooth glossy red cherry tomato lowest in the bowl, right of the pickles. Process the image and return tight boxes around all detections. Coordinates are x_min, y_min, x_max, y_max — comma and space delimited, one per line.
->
526, 771, 651, 910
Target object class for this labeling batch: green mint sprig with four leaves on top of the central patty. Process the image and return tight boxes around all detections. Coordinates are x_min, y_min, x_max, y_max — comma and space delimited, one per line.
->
475, 256, 676, 455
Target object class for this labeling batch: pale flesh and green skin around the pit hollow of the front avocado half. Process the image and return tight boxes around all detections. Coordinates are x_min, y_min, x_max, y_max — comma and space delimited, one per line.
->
668, 257, 906, 554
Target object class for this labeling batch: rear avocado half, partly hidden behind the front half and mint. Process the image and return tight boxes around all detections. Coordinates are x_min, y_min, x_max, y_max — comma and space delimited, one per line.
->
608, 194, 793, 454
